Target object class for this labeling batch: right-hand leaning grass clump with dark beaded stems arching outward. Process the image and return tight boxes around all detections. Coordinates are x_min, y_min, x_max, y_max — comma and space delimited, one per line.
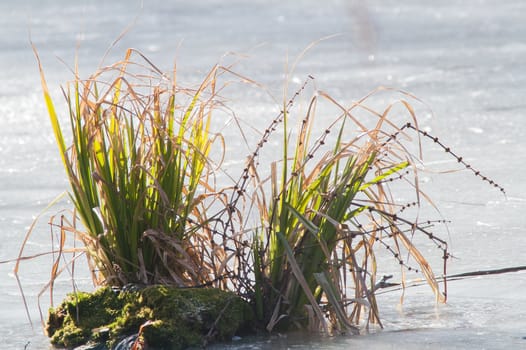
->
228, 83, 504, 333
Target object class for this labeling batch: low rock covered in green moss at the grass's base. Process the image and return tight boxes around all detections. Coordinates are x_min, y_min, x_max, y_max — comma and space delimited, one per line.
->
46, 286, 253, 349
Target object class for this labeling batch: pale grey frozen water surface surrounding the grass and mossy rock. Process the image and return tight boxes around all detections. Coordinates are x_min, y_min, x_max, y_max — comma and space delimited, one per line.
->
0, 0, 526, 349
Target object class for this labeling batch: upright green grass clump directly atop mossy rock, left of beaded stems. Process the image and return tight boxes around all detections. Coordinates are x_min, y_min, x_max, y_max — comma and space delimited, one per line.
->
32, 50, 236, 286
